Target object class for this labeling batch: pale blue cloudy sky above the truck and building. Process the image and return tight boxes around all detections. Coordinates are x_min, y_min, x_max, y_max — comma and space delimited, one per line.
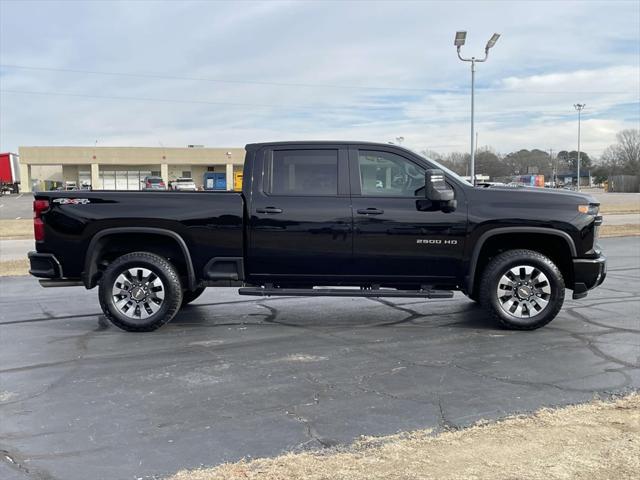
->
0, 0, 640, 157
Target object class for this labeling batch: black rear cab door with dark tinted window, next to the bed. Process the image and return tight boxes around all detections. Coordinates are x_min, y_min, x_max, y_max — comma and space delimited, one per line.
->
247, 145, 353, 281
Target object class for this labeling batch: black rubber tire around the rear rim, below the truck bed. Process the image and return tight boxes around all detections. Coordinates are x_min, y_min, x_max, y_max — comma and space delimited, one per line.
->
98, 253, 182, 331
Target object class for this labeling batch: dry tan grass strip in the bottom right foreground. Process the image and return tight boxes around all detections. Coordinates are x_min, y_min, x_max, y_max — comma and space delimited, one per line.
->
171, 394, 640, 480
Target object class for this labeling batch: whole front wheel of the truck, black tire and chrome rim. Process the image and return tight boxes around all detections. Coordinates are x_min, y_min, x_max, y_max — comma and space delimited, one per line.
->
479, 250, 565, 330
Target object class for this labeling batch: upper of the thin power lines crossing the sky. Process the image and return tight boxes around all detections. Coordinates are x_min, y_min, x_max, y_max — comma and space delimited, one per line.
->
0, 64, 629, 95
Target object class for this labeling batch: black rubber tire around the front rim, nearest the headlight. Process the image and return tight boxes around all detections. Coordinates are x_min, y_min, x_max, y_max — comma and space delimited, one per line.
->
482, 250, 565, 330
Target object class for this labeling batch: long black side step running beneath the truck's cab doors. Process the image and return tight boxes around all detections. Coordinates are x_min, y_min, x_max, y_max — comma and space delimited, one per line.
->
238, 285, 453, 298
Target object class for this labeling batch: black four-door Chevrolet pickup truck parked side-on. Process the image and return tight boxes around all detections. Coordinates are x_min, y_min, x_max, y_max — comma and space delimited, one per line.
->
29, 142, 606, 331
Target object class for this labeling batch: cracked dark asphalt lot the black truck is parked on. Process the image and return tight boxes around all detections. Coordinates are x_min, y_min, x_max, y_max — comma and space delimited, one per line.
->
0, 237, 640, 480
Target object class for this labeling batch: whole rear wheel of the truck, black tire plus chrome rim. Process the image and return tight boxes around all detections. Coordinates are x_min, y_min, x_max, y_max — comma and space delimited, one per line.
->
98, 252, 182, 332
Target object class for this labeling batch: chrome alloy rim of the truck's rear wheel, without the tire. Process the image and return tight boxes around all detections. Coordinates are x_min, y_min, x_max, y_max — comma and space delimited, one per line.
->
111, 268, 165, 319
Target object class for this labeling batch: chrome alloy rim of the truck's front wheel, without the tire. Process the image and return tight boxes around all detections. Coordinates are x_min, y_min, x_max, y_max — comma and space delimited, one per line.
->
496, 265, 551, 318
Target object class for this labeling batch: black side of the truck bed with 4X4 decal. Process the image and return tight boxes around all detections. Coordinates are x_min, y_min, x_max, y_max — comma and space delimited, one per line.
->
34, 190, 244, 286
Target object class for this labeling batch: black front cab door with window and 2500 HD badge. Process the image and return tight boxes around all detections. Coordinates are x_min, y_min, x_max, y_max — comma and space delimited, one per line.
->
349, 146, 467, 283
